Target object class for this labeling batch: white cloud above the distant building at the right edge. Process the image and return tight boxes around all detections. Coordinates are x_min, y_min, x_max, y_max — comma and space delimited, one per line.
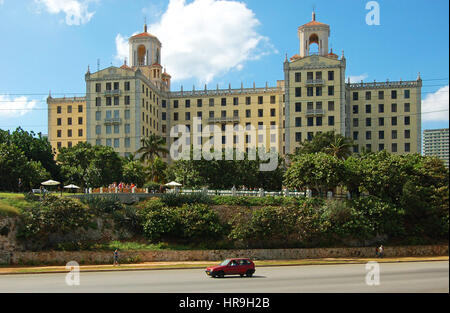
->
422, 85, 449, 122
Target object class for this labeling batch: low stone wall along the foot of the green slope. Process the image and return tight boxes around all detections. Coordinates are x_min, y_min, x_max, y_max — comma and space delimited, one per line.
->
10, 245, 448, 265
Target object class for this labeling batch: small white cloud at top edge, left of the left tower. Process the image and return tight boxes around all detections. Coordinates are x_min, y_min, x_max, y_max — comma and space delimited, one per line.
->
34, 0, 95, 25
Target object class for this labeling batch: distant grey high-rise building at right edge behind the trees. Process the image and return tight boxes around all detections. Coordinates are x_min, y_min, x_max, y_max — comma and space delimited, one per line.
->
423, 128, 449, 168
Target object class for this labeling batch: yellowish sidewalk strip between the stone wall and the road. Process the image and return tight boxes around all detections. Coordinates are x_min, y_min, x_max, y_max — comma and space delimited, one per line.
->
0, 256, 449, 275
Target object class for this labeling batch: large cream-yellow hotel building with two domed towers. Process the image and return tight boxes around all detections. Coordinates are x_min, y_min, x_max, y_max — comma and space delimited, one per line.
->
47, 13, 422, 161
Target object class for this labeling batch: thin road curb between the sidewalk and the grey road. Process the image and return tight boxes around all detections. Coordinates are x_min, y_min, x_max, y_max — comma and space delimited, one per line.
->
0, 256, 449, 276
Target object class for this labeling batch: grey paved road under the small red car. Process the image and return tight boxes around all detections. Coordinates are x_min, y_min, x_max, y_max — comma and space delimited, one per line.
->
0, 262, 449, 293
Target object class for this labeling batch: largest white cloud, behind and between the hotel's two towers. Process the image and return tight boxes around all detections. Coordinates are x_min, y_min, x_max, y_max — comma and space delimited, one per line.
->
116, 0, 278, 83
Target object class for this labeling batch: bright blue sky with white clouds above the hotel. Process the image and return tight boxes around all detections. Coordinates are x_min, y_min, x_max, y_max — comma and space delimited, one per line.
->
0, 0, 449, 133
